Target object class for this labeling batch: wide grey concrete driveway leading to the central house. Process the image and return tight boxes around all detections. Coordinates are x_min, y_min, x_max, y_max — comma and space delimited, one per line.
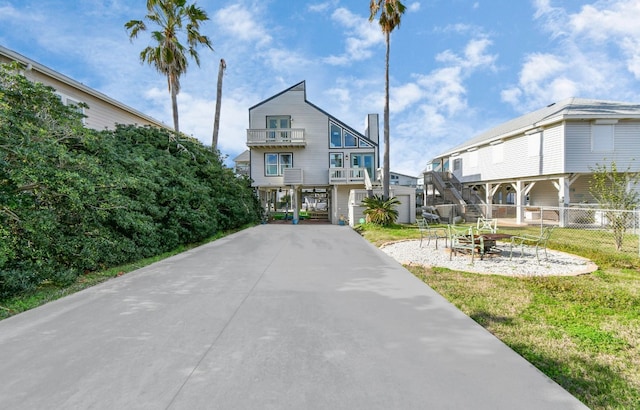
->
0, 225, 585, 410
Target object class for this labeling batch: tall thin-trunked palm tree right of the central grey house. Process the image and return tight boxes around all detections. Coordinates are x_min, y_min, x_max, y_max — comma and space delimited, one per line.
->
369, 0, 405, 199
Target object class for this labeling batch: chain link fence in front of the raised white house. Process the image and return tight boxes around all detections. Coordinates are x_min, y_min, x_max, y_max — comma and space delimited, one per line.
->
422, 204, 640, 256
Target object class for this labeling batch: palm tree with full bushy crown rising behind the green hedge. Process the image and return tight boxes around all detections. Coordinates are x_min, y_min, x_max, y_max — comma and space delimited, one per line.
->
124, 0, 213, 132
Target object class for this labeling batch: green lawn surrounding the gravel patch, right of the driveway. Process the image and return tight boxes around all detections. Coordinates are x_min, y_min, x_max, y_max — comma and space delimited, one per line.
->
358, 225, 640, 409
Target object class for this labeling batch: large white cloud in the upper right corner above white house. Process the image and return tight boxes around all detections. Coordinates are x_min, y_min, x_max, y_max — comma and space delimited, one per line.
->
502, 0, 640, 111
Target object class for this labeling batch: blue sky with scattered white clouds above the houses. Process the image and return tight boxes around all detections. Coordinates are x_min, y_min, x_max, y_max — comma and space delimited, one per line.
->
0, 0, 640, 175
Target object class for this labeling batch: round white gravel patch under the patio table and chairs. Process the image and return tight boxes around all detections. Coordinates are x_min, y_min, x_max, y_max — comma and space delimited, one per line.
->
381, 240, 598, 276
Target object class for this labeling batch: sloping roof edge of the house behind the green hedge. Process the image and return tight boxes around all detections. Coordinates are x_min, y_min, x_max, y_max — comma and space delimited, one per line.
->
0, 45, 170, 129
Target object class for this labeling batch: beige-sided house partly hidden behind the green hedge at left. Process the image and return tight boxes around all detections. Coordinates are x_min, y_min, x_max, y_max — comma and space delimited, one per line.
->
0, 46, 171, 130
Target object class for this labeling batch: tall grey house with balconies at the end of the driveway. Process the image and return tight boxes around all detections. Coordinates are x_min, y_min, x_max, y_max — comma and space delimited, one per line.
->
246, 81, 415, 225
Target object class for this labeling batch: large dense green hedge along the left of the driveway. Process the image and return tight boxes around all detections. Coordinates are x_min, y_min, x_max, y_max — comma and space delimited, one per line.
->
0, 65, 260, 299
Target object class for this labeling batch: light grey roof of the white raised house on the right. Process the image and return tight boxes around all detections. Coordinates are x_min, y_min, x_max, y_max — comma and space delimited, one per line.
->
438, 97, 640, 157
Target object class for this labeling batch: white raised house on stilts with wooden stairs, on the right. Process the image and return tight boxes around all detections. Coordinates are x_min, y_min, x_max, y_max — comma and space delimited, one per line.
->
424, 98, 640, 226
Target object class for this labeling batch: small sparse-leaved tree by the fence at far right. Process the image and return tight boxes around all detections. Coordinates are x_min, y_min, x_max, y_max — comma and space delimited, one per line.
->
589, 162, 640, 250
